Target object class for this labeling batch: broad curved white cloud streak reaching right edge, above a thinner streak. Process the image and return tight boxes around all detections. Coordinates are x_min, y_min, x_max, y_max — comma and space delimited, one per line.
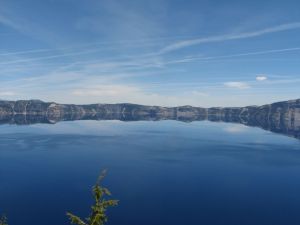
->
159, 22, 300, 54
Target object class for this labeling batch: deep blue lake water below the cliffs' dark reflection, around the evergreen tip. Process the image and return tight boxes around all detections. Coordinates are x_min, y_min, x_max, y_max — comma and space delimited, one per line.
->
0, 121, 300, 225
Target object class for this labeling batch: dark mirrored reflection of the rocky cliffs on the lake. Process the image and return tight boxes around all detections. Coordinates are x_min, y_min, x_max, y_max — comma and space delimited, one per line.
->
0, 111, 300, 139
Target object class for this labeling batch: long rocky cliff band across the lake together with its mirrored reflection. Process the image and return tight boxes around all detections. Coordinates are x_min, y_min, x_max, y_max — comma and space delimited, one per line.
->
0, 99, 300, 138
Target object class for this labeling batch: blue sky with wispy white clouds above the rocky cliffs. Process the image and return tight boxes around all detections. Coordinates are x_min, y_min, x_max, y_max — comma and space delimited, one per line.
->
0, 0, 300, 107
